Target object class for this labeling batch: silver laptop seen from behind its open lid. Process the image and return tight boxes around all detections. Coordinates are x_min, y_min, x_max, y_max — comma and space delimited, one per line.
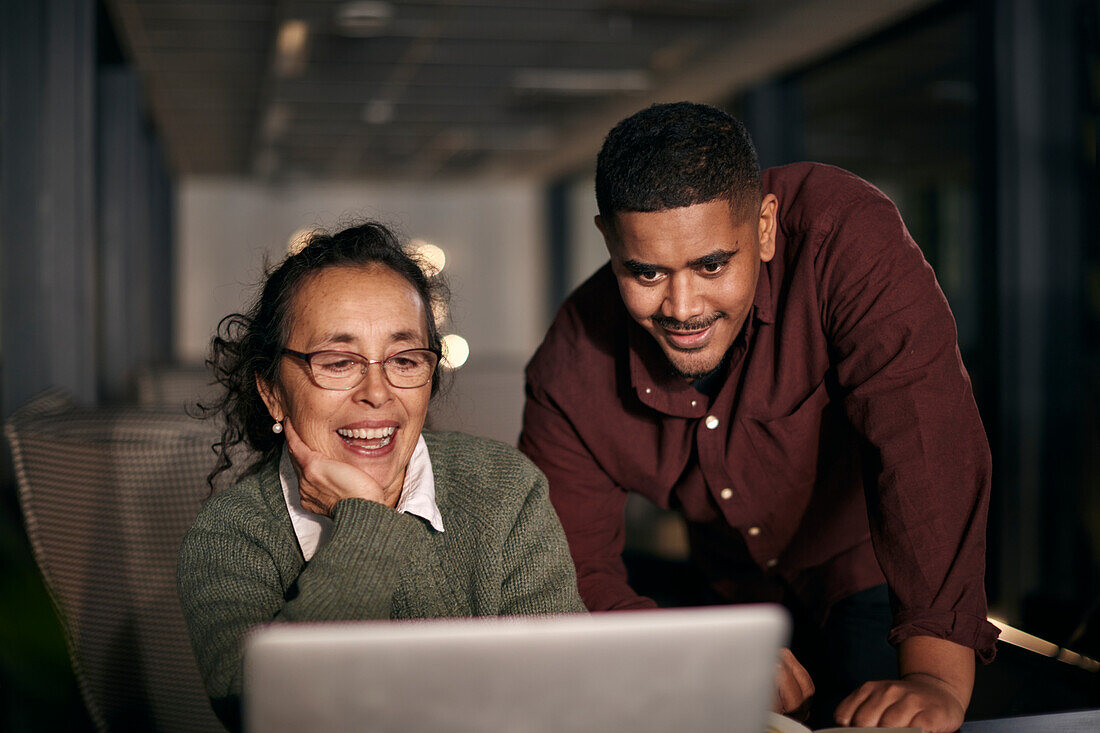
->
243, 605, 789, 733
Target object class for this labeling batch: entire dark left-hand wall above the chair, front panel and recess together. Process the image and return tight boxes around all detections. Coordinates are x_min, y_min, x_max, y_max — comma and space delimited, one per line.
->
0, 0, 173, 416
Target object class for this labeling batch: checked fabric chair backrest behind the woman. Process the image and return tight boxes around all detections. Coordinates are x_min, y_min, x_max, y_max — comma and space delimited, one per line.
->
4, 392, 229, 732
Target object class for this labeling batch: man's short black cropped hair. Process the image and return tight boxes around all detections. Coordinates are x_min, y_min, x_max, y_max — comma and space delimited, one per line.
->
596, 102, 760, 226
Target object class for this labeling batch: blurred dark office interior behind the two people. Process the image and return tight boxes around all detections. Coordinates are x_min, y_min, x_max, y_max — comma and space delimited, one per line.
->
0, 0, 1100, 730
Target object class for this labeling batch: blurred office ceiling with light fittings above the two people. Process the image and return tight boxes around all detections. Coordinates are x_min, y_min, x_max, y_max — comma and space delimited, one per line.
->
107, 0, 928, 178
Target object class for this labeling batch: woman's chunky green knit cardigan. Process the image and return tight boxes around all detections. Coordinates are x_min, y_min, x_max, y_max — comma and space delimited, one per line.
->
178, 431, 584, 727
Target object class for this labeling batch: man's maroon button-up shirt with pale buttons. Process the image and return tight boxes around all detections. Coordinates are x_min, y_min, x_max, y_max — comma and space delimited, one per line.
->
519, 163, 997, 658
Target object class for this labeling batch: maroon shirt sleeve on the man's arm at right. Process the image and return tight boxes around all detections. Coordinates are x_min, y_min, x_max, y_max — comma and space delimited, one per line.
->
815, 188, 997, 660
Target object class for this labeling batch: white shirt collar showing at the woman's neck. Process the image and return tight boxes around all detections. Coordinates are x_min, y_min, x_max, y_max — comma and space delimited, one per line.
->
278, 435, 443, 562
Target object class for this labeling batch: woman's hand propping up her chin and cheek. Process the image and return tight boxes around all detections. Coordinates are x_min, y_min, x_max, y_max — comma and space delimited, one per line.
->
283, 419, 385, 516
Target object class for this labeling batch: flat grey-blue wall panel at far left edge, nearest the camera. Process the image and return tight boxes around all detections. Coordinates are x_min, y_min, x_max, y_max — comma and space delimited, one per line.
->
0, 0, 96, 415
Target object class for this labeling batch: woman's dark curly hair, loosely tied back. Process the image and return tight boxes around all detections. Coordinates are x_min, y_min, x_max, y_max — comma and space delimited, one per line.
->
199, 221, 447, 491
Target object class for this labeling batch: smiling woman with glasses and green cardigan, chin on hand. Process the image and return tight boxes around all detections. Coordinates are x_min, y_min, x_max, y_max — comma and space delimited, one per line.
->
178, 223, 584, 727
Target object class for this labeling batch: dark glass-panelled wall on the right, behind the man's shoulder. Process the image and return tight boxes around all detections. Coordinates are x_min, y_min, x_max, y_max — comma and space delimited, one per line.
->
730, 0, 1100, 644
